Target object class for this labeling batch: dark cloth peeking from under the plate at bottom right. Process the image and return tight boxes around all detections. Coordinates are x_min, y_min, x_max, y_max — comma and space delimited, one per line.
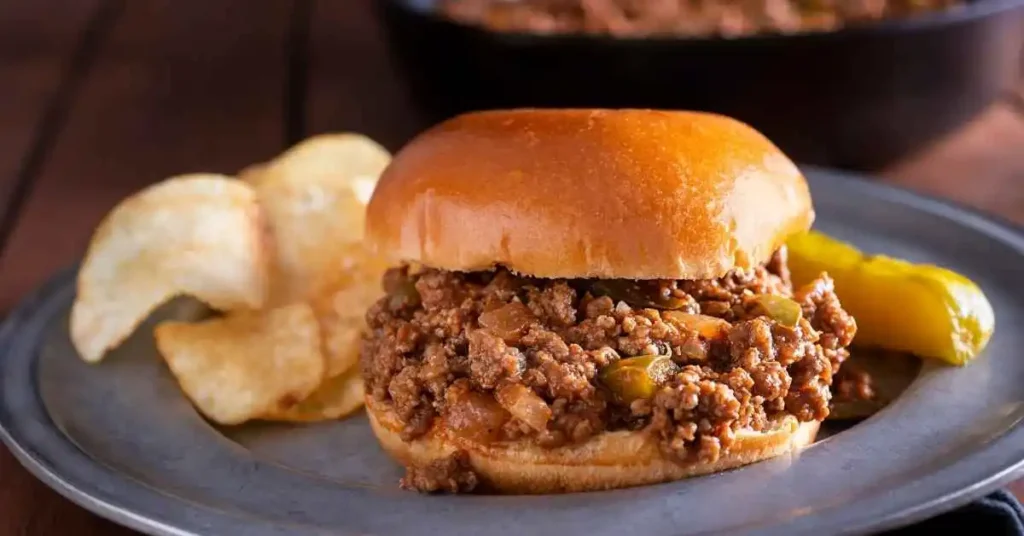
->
882, 490, 1024, 536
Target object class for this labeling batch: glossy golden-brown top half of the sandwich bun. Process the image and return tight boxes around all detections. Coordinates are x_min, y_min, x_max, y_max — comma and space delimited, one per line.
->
367, 110, 814, 279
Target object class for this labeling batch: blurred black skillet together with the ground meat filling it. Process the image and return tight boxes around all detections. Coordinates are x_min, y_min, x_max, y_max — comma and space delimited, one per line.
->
378, 0, 1022, 169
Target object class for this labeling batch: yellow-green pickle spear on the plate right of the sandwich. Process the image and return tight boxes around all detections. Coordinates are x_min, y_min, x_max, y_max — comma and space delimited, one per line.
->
786, 231, 995, 366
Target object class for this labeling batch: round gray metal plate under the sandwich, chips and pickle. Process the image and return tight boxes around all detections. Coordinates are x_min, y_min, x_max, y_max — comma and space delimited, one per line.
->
0, 169, 1024, 536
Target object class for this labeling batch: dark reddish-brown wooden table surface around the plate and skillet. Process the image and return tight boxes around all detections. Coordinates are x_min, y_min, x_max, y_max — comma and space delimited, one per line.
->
0, 0, 1024, 535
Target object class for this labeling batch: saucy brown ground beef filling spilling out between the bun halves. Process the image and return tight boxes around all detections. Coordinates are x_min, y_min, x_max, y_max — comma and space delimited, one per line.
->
362, 250, 856, 489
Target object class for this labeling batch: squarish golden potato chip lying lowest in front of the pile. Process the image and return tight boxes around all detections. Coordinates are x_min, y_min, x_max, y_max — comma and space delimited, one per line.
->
156, 303, 324, 424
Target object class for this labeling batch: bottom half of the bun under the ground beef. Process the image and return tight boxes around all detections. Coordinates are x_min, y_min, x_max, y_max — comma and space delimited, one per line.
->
366, 396, 820, 494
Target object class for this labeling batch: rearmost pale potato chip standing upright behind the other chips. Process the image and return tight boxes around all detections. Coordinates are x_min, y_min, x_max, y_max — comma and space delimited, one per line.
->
243, 133, 390, 305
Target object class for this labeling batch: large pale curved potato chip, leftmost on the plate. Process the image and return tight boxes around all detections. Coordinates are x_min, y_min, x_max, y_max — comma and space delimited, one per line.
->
71, 174, 269, 363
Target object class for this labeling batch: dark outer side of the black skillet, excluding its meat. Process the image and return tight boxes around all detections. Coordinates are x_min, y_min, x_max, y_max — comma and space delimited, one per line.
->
375, 0, 1024, 169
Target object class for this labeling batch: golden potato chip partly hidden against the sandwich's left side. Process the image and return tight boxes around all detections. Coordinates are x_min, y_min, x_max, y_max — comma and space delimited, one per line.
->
310, 243, 387, 377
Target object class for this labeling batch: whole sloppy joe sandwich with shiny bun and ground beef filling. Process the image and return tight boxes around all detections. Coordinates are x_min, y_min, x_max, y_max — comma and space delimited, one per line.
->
360, 110, 856, 493
